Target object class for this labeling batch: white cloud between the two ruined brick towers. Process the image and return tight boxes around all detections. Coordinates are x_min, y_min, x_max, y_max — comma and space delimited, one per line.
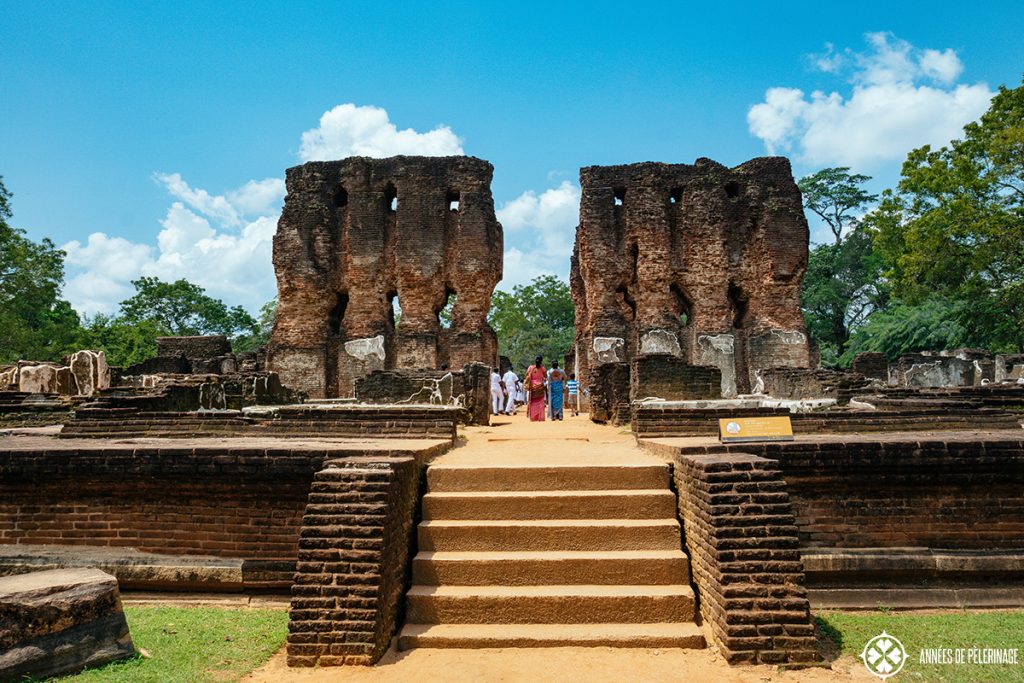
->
497, 180, 580, 290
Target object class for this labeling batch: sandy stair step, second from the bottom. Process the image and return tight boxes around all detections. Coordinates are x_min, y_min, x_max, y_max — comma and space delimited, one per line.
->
406, 585, 694, 624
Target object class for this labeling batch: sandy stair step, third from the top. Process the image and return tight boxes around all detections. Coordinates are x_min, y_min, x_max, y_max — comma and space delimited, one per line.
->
418, 518, 681, 551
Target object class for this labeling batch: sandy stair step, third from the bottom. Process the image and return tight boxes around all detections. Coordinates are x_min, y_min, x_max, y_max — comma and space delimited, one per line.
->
413, 550, 690, 586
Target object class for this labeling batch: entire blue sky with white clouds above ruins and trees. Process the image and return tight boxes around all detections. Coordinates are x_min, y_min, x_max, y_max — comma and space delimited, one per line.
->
0, 0, 1024, 313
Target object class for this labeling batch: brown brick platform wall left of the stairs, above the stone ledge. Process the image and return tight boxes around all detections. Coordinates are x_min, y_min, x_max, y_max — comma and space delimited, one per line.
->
0, 446, 325, 559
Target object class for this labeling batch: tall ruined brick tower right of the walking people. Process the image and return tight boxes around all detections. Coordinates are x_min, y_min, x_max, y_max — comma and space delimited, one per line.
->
569, 157, 810, 396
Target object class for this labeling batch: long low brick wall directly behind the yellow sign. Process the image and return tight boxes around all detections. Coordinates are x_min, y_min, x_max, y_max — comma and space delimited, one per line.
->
633, 402, 1021, 438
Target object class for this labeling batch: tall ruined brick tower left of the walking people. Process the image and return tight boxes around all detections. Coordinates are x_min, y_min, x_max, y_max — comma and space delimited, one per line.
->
268, 157, 503, 397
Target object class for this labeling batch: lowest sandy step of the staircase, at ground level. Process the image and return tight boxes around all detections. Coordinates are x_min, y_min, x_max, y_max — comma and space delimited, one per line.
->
398, 623, 705, 650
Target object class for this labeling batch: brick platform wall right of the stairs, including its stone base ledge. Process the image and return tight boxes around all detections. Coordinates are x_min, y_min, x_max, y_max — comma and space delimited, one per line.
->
643, 438, 1024, 589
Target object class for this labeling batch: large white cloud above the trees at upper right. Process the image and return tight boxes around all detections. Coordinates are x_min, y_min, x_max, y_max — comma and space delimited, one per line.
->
746, 33, 995, 171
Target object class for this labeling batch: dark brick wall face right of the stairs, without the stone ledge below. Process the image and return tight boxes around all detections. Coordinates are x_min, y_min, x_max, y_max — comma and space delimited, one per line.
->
653, 433, 1024, 552
